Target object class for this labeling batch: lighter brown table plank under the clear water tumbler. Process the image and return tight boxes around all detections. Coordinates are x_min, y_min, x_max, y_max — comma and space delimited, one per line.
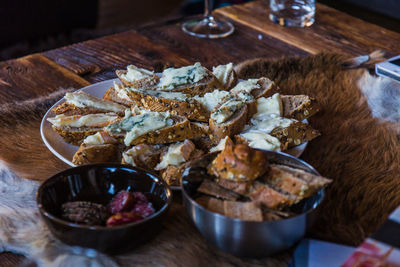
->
216, 1, 400, 55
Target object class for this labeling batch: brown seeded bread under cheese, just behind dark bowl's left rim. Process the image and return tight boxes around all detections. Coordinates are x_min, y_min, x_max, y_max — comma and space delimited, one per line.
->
72, 143, 121, 165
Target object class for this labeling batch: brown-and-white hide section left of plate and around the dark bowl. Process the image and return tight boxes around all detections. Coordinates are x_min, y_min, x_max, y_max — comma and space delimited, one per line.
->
0, 90, 291, 267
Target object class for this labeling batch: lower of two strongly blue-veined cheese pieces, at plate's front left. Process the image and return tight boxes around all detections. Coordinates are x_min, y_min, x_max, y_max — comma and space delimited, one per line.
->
107, 110, 173, 146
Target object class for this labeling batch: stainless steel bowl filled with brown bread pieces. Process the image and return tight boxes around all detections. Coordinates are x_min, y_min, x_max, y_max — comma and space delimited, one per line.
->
182, 145, 331, 258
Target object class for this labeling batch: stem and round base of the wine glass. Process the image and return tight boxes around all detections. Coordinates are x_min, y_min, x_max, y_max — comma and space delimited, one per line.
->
182, 0, 235, 38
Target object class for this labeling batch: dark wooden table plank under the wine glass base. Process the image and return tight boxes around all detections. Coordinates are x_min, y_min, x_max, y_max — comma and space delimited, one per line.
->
138, 14, 307, 67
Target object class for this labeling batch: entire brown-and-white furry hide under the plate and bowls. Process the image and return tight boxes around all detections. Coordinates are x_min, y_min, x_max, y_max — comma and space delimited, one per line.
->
0, 54, 400, 266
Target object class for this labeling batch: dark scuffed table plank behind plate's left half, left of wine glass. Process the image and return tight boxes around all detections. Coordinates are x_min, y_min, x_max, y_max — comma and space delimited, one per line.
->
43, 31, 189, 82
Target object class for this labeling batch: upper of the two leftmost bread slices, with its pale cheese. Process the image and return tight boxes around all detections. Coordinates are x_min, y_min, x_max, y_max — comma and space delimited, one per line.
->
53, 91, 126, 116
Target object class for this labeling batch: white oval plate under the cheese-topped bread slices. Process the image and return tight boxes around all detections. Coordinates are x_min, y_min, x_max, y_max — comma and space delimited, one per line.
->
40, 78, 307, 185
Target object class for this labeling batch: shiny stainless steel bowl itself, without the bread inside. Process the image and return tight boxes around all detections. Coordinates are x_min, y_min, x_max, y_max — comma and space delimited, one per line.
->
182, 151, 324, 258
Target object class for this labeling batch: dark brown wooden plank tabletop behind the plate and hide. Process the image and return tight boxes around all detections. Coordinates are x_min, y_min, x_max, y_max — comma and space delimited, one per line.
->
0, 1, 400, 266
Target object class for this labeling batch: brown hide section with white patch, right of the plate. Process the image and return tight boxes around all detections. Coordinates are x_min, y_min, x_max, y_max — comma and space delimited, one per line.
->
237, 54, 400, 245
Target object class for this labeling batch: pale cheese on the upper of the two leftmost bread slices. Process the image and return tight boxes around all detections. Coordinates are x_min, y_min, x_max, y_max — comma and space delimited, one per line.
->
64, 91, 125, 113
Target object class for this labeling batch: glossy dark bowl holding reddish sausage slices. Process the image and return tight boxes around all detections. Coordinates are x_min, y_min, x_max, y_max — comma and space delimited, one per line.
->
37, 164, 172, 254
